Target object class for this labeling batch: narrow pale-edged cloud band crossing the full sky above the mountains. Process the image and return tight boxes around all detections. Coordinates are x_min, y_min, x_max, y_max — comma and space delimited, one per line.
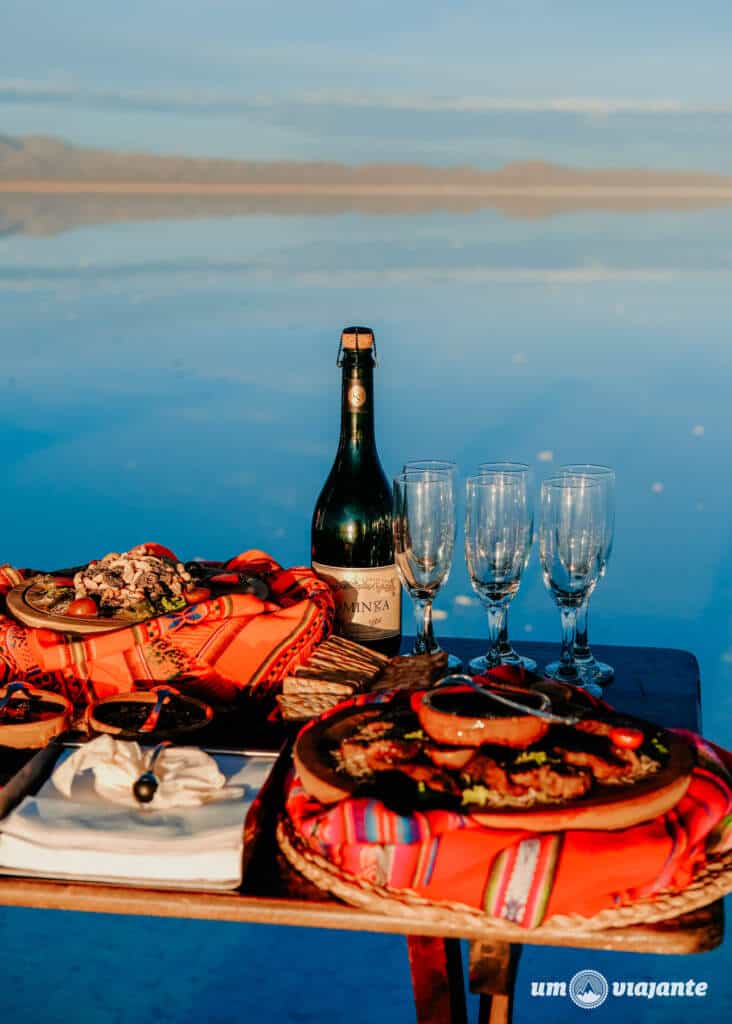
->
0, 79, 732, 117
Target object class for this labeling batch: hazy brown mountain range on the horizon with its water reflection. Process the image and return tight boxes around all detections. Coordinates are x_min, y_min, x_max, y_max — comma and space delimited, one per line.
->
0, 135, 732, 234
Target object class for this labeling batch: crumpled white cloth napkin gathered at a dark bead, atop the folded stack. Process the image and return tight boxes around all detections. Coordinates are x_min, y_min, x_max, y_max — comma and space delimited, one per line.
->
51, 735, 244, 811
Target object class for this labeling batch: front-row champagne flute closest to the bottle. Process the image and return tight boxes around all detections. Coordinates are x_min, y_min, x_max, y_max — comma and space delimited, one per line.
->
393, 469, 462, 671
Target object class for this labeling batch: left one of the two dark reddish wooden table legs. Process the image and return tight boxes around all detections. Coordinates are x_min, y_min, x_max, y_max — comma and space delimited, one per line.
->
406, 935, 467, 1024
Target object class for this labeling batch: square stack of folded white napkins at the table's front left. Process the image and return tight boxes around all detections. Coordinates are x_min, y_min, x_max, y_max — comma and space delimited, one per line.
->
0, 739, 273, 890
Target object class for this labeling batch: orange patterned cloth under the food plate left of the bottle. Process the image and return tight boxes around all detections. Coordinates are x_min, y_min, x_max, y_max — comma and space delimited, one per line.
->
0, 544, 334, 707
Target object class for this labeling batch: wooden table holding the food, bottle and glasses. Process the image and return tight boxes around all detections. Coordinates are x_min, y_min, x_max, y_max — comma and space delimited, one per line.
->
0, 640, 723, 1024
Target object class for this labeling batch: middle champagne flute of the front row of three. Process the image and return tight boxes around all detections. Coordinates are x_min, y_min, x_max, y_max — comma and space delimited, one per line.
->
465, 472, 533, 675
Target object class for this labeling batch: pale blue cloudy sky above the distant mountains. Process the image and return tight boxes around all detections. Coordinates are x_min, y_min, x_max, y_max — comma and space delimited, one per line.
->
0, 0, 732, 171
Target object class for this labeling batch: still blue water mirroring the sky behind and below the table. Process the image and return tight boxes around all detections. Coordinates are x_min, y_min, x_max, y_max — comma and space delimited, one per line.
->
0, 203, 732, 1024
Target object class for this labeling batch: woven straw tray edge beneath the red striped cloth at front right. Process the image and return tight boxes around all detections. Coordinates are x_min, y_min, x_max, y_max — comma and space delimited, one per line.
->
277, 817, 732, 940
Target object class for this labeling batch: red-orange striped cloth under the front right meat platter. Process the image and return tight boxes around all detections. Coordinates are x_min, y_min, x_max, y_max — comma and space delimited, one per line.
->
286, 697, 732, 928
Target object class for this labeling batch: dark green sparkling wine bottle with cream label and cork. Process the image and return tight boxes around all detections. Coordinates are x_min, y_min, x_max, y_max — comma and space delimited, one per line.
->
311, 327, 401, 654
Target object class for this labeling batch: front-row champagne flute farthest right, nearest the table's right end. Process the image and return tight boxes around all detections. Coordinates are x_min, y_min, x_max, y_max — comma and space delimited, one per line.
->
539, 475, 608, 694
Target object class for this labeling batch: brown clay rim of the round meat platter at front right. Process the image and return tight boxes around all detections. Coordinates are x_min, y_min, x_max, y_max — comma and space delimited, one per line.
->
293, 705, 694, 831
